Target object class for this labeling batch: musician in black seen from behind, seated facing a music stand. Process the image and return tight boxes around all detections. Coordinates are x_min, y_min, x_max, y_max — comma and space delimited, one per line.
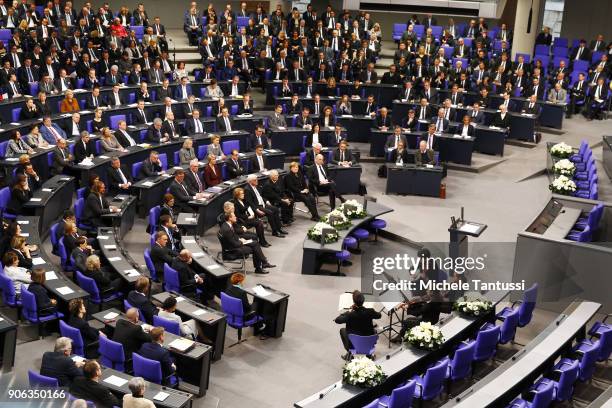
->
334, 290, 382, 359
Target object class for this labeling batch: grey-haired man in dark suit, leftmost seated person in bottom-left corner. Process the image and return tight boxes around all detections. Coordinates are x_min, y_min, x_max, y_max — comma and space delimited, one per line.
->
40, 337, 84, 387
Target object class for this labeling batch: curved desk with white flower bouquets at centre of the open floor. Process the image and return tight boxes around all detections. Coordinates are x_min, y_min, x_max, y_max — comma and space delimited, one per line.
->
302, 202, 393, 275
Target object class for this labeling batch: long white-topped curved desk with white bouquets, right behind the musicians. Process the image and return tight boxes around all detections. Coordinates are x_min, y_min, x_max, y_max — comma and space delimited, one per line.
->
294, 290, 508, 408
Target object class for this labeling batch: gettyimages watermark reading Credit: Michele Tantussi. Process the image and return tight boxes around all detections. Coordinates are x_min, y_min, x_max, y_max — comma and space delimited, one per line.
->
362, 243, 525, 301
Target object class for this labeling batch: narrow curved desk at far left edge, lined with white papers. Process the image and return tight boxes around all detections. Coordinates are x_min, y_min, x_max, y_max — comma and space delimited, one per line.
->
17, 216, 89, 311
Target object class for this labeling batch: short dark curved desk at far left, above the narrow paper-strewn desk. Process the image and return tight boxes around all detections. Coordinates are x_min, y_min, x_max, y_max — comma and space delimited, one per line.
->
23, 176, 76, 239
